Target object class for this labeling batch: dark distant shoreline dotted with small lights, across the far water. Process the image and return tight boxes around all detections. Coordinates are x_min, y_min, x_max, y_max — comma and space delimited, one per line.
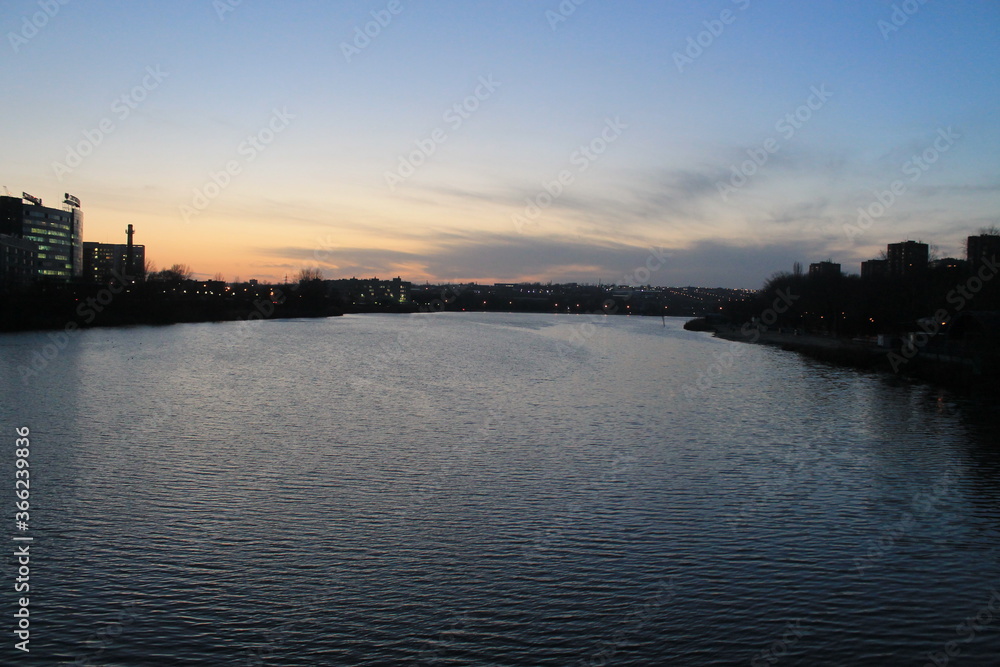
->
0, 280, 746, 333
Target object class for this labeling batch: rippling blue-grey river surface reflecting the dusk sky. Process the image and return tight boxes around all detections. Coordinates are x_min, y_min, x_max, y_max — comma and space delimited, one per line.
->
0, 314, 1000, 665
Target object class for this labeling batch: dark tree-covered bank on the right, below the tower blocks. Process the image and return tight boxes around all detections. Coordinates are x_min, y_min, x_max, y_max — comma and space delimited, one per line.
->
685, 256, 1000, 393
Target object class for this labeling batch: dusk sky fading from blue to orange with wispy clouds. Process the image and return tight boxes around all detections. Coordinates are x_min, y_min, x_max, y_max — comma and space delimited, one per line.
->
0, 0, 1000, 288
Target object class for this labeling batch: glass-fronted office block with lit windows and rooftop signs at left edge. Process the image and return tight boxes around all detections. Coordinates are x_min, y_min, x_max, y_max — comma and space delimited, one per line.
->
0, 193, 83, 282
